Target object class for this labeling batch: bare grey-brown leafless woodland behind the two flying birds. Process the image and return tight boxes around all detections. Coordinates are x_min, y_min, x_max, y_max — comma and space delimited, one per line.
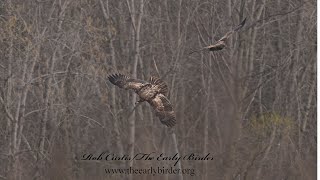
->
0, 0, 317, 180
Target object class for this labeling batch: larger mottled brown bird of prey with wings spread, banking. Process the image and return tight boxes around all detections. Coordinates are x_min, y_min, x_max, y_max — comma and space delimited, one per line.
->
108, 74, 176, 127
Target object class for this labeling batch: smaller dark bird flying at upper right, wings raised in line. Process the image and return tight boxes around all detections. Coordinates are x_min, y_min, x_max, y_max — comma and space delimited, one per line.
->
189, 18, 247, 55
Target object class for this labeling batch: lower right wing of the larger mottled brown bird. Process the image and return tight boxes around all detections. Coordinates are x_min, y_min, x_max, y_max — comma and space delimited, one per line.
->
148, 94, 176, 127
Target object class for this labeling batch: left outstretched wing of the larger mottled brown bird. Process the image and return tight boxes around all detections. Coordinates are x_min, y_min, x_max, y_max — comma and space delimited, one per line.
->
108, 74, 148, 91
